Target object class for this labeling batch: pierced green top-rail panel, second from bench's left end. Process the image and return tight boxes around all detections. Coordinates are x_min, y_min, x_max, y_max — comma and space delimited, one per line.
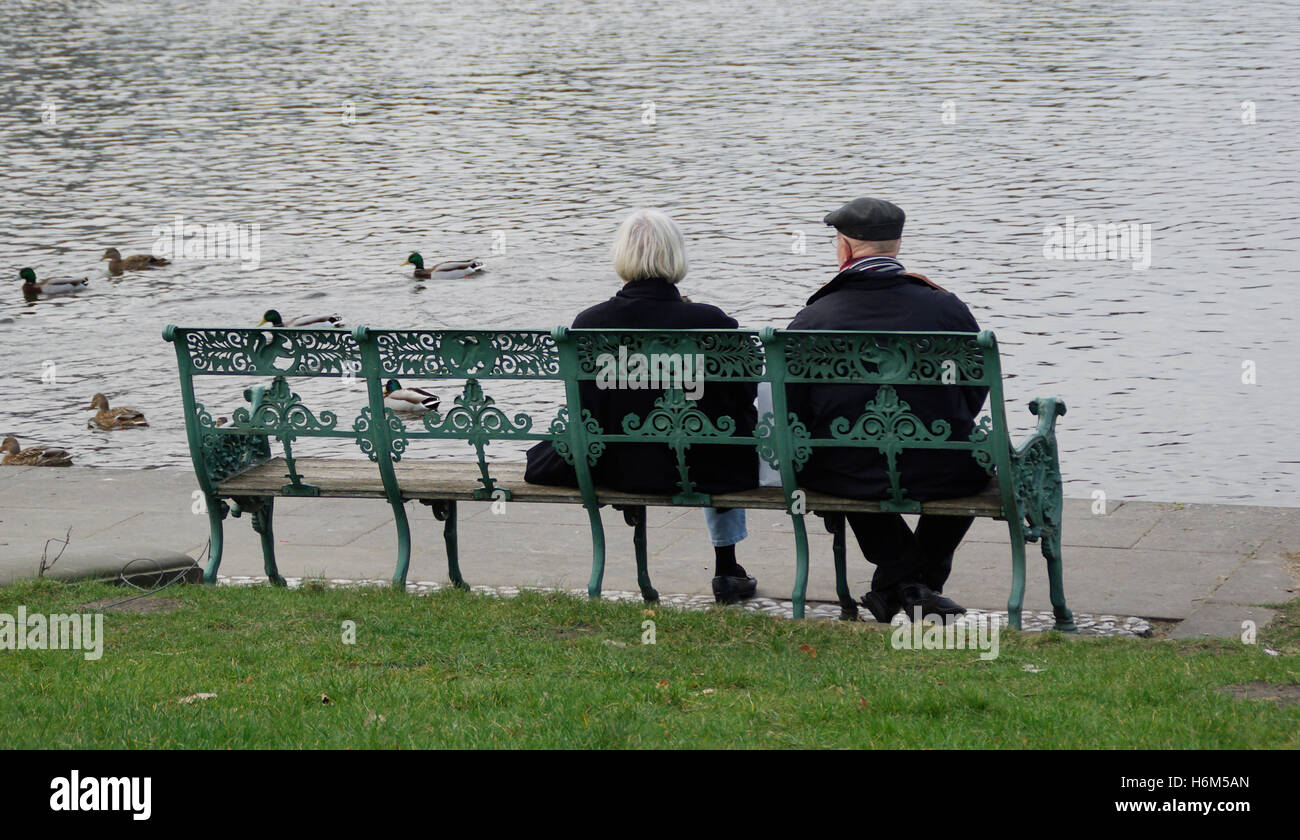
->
374, 330, 560, 378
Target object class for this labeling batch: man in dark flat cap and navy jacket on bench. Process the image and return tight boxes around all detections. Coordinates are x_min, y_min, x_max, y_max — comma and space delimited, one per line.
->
788, 198, 988, 623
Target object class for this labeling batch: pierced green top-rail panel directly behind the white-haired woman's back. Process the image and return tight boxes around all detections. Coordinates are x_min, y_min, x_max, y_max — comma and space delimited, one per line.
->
573, 330, 766, 380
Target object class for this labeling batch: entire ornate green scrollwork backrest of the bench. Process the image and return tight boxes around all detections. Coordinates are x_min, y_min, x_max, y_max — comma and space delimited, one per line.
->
166, 328, 1008, 517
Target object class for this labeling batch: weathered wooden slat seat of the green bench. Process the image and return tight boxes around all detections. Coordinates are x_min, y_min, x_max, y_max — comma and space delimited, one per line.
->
218, 458, 1002, 518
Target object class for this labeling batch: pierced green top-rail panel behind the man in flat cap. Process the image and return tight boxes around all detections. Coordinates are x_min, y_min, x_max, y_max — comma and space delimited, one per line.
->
784, 332, 984, 385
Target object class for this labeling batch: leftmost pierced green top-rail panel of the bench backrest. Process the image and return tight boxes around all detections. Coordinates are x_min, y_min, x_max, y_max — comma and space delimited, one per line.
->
185, 328, 361, 376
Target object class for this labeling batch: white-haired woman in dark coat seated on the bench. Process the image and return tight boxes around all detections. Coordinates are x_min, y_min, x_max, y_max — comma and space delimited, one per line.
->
525, 209, 758, 603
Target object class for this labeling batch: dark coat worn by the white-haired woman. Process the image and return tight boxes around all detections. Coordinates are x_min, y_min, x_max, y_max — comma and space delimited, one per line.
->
524, 280, 758, 493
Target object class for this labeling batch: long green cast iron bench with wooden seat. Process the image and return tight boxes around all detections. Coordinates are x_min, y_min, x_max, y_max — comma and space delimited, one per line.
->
163, 325, 1074, 631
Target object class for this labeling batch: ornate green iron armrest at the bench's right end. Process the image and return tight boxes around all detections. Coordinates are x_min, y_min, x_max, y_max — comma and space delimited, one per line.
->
1011, 397, 1065, 544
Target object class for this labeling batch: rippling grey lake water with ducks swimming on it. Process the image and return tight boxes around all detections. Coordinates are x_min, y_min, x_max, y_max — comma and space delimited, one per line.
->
0, 0, 1300, 506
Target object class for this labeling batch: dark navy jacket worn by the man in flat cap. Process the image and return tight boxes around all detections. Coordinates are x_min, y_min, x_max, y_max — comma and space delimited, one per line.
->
787, 270, 988, 502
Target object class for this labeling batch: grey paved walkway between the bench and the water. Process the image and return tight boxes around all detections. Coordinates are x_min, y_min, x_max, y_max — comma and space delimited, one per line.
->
0, 467, 1300, 637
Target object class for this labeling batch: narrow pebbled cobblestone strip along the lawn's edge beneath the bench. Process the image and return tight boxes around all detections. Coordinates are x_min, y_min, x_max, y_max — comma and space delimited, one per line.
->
217, 575, 1152, 637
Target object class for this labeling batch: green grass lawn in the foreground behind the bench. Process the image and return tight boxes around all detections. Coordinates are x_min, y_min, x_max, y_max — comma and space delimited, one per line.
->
0, 581, 1300, 749
